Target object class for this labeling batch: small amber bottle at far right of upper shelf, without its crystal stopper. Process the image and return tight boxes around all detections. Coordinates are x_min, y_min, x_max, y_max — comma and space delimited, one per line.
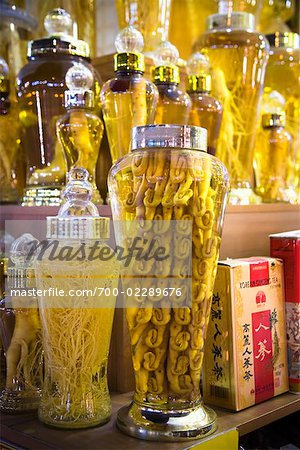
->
254, 112, 296, 203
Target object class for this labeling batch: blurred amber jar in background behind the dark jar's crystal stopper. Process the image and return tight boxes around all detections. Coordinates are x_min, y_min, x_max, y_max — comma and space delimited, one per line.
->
26, 0, 96, 57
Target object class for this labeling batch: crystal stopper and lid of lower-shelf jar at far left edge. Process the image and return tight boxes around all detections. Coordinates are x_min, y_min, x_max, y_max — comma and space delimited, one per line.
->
7, 233, 39, 289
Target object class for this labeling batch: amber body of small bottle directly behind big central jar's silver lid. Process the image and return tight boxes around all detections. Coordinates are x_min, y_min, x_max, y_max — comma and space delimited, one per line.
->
154, 83, 192, 125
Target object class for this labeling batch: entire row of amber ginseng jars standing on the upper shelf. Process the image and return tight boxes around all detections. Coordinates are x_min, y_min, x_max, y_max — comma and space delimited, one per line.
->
1, 2, 299, 205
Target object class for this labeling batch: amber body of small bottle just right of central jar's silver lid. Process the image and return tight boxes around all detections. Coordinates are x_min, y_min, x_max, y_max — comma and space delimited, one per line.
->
188, 92, 222, 155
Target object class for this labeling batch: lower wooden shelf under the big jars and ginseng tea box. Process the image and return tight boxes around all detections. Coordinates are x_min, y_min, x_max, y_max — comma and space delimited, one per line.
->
1, 393, 300, 450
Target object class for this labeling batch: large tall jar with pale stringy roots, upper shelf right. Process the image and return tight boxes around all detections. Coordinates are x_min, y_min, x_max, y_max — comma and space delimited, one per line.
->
195, 0, 269, 204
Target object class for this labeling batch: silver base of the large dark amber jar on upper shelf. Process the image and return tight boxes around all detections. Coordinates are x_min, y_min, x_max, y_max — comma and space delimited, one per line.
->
22, 186, 64, 206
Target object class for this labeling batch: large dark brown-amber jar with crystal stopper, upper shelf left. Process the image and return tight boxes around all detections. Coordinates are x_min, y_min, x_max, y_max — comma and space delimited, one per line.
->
17, 9, 99, 206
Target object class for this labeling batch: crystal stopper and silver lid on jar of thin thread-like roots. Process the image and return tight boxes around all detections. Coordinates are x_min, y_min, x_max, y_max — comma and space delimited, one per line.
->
47, 168, 109, 240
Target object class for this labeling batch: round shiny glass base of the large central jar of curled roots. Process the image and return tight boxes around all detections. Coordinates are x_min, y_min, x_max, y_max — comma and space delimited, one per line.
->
117, 402, 217, 441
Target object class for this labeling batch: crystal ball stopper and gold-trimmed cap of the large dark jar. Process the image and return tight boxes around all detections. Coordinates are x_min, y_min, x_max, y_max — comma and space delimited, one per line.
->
27, 8, 90, 58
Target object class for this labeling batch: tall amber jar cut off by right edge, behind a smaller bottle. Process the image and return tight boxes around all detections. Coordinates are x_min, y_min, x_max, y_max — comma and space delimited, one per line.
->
264, 33, 300, 196
